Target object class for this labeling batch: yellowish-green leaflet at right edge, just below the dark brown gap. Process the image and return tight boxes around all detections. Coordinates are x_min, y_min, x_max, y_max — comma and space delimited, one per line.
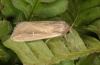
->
81, 35, 100, 52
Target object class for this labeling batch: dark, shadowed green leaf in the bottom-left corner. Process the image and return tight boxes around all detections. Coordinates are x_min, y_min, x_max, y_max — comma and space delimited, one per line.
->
0, 39, 20, 65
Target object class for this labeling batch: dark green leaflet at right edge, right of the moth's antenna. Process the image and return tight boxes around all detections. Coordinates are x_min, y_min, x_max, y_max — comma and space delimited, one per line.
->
76, 7, 100, 25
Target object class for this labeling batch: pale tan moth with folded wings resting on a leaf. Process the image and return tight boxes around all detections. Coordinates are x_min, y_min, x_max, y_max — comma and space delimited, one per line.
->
11, 21, 70, 42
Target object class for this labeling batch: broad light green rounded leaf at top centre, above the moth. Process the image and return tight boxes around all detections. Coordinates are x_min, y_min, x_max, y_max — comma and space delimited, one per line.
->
33, 0, 68, 18
